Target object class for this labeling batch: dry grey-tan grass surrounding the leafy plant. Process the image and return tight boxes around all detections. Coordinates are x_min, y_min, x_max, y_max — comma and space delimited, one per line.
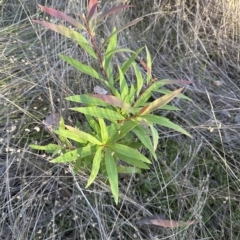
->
0, 0, 240, 240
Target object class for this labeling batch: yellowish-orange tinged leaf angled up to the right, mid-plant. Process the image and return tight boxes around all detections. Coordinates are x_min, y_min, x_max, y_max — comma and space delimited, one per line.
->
140, 88, 183, 115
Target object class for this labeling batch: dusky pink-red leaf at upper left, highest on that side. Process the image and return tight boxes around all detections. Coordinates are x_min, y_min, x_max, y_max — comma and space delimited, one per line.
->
38, 5, 86, 30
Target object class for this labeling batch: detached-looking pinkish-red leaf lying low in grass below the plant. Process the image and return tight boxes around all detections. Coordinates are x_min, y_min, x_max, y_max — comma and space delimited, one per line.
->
137, 215, 195, 228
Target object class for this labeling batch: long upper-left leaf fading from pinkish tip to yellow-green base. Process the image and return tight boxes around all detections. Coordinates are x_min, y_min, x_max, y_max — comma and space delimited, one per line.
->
32, 20, 97, 59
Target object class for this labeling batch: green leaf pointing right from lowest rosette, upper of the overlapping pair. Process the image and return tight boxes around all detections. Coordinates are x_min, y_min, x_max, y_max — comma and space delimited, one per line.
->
109, 143, 151, 163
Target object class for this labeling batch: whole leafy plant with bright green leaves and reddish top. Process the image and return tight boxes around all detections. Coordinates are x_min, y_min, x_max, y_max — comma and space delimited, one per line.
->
30, 0, 190, 203
